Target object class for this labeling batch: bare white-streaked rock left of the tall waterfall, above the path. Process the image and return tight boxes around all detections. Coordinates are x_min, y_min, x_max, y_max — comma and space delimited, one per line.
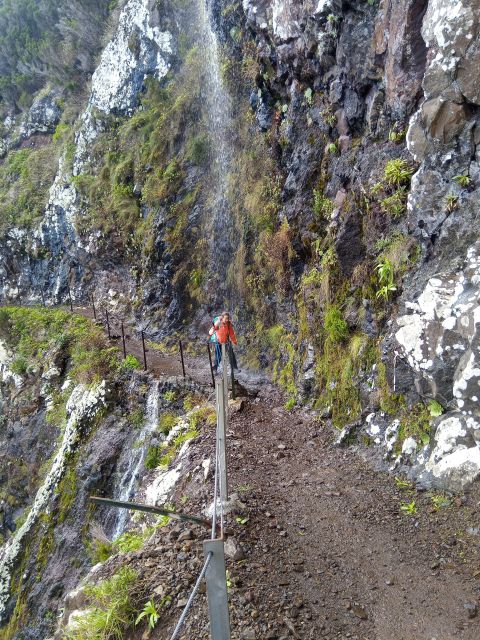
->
0, 0, 173, 304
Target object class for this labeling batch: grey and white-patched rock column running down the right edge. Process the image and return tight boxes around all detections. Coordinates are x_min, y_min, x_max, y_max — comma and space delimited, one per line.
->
384, 0, 480, 490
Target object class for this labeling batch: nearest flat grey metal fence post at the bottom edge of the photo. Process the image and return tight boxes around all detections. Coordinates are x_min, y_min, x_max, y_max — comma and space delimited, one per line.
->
203, 539, 230, 640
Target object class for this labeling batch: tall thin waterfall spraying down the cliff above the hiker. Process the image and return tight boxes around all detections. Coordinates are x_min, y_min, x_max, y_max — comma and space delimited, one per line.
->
196, 0, 233, 295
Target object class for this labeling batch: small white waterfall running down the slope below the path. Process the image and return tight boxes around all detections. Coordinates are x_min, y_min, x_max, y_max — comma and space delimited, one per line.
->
113, 380, 160, 540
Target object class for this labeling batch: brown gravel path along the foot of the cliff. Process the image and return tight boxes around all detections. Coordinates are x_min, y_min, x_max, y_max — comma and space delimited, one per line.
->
81, 308, 480, 640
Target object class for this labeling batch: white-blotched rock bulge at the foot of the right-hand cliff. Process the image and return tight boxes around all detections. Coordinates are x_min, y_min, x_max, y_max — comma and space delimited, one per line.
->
395, 244, 480, 490
